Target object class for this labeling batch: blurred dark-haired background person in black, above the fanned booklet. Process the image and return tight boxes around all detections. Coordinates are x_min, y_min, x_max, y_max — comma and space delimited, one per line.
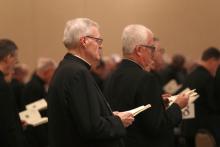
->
159, 55, 187, 85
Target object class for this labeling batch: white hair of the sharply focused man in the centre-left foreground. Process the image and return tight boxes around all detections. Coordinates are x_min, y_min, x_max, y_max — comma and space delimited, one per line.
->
63, 18, 99, 49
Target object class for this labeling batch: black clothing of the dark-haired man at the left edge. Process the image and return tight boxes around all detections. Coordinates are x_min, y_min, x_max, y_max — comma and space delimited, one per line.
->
0, 71, 27, 147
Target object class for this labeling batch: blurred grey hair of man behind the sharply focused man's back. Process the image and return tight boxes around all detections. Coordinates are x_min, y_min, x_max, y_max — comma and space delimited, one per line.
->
37, 57, 57, 71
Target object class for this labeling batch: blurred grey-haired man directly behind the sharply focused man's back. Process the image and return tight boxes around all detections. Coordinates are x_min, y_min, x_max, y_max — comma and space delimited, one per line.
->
22, 58, 56, 147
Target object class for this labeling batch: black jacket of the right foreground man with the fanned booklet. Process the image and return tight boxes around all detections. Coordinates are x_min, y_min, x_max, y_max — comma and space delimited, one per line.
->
104, 59, 182, 147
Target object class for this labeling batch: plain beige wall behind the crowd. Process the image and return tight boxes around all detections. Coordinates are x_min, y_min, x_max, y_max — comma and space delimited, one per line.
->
0, 0, 220, 68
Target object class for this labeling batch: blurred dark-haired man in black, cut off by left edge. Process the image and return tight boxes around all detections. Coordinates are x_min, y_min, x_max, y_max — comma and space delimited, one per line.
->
0, 39, 26, 147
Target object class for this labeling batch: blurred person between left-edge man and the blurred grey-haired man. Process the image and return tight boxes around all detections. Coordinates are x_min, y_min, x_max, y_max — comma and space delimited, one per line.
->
11, 64, 29, 112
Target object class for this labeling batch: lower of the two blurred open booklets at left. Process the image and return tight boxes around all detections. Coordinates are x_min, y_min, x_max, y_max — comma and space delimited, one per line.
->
19, 109, 48, 127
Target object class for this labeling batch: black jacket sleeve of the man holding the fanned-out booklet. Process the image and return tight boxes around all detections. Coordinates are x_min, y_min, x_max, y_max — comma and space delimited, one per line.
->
136, 74, 182, 135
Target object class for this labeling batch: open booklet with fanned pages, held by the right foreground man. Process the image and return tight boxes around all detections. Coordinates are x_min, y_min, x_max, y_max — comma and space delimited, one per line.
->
168, 88, 199, 106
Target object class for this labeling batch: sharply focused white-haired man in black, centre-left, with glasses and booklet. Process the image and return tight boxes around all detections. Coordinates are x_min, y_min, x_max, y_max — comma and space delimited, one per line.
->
48, 18, 134, 147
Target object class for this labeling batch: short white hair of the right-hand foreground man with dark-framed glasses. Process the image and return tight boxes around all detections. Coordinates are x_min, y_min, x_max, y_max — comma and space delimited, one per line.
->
122, 24, 153, 54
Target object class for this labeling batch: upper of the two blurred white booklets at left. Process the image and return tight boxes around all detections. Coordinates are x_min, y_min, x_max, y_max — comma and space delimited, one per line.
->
25, 98, 47, 110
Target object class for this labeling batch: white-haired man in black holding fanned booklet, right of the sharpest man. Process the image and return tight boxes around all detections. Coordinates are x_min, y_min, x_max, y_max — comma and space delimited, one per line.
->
104, 25, 188, 147
